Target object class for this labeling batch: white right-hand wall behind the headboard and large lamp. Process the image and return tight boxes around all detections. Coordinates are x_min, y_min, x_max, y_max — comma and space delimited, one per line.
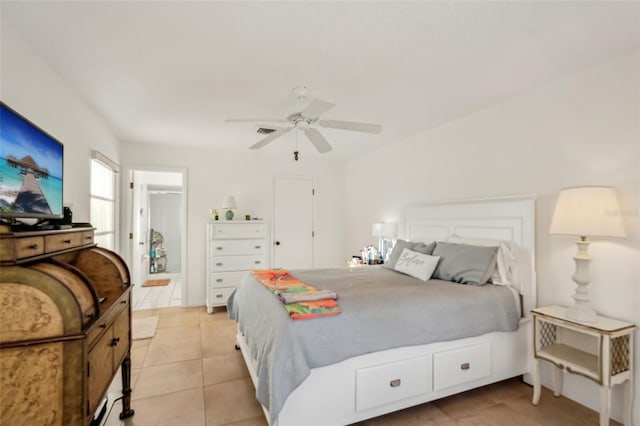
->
345, 52, 640, 423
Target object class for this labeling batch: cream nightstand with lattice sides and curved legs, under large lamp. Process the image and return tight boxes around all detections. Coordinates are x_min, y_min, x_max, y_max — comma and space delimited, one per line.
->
532, 306, 636, 426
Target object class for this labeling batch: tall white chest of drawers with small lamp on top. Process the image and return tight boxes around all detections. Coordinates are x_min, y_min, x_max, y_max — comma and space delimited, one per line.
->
206, 221, 268, 313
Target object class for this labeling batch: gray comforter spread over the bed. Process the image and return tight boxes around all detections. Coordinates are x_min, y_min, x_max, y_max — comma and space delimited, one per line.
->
228, 267, 519, 423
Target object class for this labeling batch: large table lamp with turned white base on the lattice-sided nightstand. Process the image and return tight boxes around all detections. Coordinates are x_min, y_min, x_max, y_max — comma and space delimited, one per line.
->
549, 186, 626, 322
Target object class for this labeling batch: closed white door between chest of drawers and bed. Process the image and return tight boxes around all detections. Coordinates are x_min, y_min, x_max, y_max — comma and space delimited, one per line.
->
272, 177, 314, 269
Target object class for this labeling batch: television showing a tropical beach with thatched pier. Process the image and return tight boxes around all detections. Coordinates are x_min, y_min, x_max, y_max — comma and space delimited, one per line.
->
0, 102, 64, 219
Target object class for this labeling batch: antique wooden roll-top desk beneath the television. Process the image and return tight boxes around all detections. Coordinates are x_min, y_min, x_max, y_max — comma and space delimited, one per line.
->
0, 225, 133, 426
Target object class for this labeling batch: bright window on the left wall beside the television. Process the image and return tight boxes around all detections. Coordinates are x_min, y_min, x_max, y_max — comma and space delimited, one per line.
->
91, 151, 118, 251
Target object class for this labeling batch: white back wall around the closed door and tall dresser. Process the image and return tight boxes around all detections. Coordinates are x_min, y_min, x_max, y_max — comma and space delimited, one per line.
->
121, 143, 347, 306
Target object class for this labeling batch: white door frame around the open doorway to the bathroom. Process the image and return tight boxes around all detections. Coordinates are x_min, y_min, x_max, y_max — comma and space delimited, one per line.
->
123, 164, 189, 306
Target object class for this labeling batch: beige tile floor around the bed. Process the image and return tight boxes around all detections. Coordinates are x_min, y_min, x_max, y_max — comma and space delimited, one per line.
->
105, 307, 618, 426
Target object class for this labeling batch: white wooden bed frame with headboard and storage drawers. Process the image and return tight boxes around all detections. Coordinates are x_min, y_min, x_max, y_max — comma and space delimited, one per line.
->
237, 196, 537, 426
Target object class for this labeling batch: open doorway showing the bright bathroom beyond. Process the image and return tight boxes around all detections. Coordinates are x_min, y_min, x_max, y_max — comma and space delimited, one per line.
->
129, 167, 187, 310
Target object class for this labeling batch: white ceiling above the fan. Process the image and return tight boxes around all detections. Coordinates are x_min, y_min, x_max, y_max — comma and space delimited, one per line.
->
1, 1, 640, 159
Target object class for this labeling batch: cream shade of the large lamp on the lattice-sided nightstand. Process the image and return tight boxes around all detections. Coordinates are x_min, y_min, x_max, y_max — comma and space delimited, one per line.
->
549, 186, 626, 238
